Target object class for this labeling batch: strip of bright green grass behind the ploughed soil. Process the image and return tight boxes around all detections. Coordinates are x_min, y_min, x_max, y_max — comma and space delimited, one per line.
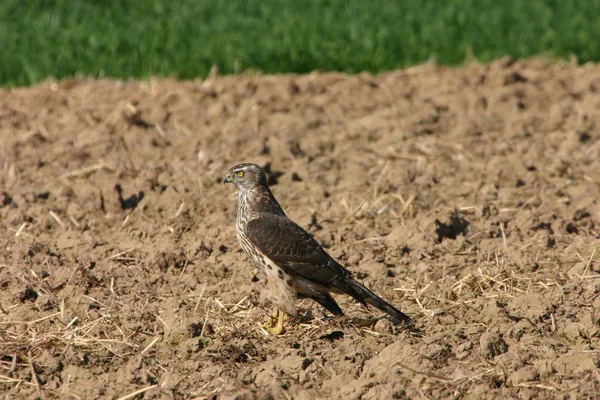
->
0, 0, 600, 86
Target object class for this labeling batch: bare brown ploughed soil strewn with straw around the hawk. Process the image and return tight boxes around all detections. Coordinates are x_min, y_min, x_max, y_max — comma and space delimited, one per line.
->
0, 59, 600, 399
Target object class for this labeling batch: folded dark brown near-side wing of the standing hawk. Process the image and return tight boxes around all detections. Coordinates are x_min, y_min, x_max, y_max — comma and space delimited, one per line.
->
246, 214, 351, 284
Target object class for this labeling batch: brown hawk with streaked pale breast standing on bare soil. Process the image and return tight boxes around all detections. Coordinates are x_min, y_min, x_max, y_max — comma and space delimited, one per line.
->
223, 163, 413, 335
